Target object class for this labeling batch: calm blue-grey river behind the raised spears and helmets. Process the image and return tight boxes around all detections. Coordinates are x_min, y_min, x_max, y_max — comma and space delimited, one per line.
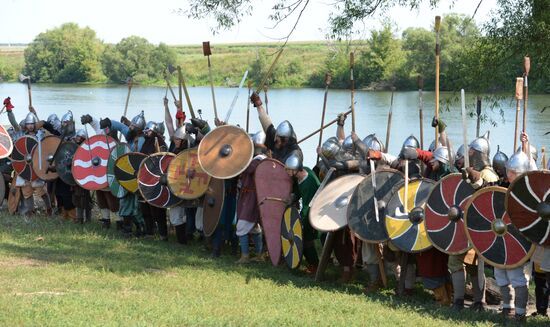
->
0, 83, 550, 165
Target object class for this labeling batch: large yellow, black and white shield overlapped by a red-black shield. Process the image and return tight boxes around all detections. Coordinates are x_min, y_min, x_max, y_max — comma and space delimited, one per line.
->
385, 179, 435, 253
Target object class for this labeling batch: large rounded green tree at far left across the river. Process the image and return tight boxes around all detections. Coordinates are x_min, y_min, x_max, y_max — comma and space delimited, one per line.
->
23, 23, 103, 83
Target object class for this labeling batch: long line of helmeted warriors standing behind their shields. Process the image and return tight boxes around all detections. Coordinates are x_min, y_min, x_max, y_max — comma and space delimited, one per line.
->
4, 93, 550, 321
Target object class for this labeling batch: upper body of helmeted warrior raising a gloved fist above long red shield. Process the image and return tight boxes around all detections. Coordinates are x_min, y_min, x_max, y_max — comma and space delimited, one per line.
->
250, 92, 304, 162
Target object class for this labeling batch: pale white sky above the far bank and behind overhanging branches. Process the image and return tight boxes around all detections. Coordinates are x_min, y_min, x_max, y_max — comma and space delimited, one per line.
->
0, 0, 496, 45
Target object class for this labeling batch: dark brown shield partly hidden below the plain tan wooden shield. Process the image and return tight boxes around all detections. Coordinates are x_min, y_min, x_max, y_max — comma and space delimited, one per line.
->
202, 178, 225, 237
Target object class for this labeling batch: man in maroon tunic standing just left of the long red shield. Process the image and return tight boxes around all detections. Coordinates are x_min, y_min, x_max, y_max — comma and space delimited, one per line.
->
236, 131, 267, 263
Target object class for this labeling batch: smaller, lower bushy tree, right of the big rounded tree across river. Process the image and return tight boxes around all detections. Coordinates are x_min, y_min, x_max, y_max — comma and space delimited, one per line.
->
101, 36, 176, 83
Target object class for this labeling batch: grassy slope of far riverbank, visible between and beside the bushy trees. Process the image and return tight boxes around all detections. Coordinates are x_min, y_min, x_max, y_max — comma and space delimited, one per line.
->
0, 41, 330, 87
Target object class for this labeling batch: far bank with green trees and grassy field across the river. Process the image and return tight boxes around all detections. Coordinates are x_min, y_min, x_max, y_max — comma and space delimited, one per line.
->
0, 14, 550, 93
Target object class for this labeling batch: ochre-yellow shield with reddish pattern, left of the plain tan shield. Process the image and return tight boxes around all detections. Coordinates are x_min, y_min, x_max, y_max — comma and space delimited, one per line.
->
168, 148, 210, 200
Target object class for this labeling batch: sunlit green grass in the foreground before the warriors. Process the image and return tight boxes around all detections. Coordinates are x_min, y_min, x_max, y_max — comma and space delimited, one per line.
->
0, 214, 547, 326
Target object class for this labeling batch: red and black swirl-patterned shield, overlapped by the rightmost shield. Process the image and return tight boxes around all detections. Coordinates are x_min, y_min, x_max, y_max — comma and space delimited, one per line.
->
464, 186, 535, 269
